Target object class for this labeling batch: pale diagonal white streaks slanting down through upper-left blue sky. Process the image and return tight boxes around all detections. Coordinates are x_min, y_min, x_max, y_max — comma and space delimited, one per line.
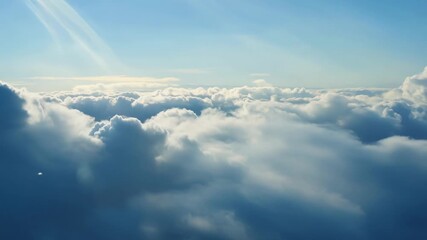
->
26, 0, 119, 70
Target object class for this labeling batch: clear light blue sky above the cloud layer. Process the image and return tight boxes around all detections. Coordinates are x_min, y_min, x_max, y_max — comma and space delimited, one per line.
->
0, 0, 427, 88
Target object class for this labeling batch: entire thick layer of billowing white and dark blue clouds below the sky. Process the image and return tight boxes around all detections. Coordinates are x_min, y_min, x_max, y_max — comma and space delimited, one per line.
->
0, 66, 427, 239
